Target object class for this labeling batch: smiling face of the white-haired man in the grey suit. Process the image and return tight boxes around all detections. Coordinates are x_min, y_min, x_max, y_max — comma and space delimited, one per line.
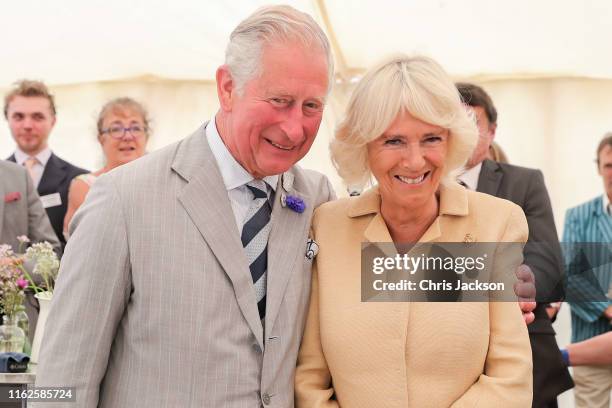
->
218, 43, 328, 178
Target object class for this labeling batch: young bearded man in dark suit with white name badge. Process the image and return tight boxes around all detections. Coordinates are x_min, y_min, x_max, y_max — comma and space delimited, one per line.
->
4, 80, 88, 246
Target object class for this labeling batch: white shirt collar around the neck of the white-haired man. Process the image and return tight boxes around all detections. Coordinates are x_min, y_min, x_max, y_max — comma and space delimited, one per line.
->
206, 117, 278, 191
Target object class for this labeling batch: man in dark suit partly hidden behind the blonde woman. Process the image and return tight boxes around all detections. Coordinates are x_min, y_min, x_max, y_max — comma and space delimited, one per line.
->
457, 83, 573, 407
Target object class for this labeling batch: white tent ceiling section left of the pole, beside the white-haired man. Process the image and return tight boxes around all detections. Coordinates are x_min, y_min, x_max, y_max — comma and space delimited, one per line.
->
0, 0, 314, 86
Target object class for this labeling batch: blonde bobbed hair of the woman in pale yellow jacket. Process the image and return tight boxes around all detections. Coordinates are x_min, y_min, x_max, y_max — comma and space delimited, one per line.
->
330, 55, 478, 187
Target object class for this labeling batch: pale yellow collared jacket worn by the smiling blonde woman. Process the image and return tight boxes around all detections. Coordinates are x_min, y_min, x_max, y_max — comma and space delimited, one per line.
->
295, 185, 532, 408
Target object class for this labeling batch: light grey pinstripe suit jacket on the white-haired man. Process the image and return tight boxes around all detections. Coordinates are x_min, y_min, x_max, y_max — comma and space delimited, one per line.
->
36, 126, 334, 408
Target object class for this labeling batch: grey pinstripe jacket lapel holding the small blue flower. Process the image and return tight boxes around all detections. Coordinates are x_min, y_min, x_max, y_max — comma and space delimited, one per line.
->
265, 169, 314, 330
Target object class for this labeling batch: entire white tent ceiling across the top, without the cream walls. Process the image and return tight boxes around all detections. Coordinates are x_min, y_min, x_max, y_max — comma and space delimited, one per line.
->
0, 0, 612, 87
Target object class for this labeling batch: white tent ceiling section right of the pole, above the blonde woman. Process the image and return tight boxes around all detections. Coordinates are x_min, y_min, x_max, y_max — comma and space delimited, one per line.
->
324, 0, 612, 78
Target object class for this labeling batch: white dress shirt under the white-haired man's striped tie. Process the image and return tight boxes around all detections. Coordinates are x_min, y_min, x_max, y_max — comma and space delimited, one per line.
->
206, 117, 278, 233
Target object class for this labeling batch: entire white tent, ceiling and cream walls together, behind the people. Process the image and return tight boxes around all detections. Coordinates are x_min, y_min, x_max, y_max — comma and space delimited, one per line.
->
0, 0, 612, 406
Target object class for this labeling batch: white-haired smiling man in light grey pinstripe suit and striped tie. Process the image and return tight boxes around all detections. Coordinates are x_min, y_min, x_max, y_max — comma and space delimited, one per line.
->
36, 6, 334, 408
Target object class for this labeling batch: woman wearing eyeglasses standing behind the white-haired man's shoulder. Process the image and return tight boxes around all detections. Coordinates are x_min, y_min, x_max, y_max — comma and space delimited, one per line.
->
64, 98, 150, 239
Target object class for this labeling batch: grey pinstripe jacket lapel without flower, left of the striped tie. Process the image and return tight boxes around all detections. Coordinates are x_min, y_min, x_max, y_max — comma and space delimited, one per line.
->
172, 125, 264, 349
